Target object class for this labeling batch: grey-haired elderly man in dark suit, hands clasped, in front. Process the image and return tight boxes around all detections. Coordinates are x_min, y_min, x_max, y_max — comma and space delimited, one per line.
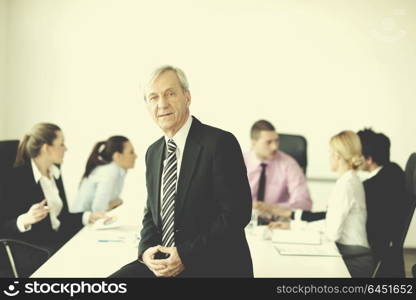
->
112, 66, 253, 277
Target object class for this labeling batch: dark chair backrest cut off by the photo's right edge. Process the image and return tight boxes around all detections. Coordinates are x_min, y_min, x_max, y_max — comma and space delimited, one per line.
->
401, 153, 416, 245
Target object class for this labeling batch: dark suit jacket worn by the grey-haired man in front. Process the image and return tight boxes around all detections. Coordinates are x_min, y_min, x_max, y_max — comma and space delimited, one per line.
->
139, 118, 253, 277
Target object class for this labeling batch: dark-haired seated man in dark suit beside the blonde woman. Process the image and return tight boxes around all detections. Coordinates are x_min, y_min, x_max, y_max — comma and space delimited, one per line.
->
358, 129, 406, 277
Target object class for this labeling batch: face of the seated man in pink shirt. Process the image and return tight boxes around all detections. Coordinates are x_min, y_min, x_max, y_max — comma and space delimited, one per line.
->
251, 130, 279, 160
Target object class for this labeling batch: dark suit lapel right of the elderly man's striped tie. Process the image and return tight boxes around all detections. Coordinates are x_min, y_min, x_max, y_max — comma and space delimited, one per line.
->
175, 118, 202, 220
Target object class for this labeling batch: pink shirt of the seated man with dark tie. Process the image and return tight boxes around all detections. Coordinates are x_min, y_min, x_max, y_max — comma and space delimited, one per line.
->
244, 151, 312, 210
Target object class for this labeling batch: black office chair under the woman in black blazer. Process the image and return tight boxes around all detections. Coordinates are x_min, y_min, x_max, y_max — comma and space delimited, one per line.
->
0, 140, 51, 278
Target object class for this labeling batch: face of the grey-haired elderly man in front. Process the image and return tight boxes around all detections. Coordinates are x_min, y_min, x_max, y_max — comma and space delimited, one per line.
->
146, 70, 191, 137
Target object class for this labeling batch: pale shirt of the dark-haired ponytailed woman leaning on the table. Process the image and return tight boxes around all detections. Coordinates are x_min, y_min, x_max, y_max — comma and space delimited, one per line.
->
71, 162, 127, 212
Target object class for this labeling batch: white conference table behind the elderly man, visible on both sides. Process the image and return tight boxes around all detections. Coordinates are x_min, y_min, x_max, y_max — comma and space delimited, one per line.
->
31, 225, 350, 278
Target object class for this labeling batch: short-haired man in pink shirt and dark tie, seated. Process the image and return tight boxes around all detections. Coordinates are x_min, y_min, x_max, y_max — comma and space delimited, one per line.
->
244, 120, 312, 210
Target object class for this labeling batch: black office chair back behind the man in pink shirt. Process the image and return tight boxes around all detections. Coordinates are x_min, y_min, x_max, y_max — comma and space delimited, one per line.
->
279, 133, 308, 174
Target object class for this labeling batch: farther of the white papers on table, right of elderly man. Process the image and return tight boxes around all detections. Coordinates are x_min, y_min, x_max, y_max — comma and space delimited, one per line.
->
272, 229, 321, 245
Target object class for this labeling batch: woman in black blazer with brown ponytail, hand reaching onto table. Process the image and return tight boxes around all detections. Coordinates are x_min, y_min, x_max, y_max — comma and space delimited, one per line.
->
0, 123, 105, 252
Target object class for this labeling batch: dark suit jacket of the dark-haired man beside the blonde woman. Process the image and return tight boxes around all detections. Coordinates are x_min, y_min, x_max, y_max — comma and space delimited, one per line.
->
364, 163, 407, 277
